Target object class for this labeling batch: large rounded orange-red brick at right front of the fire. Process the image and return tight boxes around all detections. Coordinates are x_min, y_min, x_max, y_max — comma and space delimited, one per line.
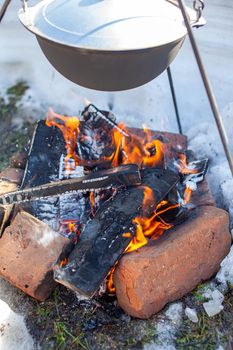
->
114, 206, 231, 319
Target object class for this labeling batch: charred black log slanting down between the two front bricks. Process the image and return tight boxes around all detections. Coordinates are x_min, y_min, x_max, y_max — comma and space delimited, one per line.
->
54, 168, 178, 296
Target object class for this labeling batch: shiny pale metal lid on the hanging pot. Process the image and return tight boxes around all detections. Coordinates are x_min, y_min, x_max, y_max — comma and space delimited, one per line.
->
19, 0, 199, 51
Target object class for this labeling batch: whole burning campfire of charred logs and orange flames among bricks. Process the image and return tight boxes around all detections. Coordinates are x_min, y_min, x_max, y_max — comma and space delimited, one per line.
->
0, 104, 231, 320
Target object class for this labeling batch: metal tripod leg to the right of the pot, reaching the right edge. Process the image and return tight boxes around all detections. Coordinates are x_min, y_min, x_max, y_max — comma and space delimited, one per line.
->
178, 0, 233, 176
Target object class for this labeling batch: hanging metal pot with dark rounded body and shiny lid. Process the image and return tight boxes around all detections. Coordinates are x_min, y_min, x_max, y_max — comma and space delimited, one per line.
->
19, 0, 205, 91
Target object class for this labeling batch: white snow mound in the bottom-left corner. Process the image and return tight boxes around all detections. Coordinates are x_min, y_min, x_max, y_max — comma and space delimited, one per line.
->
0, 299, 35, 350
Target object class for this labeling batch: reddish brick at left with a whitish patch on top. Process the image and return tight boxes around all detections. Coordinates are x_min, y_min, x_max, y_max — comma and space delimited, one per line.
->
0, 211, 68, 301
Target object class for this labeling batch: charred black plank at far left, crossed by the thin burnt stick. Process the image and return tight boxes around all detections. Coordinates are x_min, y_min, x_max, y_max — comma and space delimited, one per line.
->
16, 120, 66, 229
